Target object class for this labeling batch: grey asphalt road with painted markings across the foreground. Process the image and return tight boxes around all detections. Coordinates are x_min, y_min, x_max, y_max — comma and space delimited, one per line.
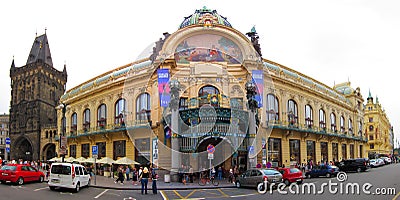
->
0, 164, 400, 200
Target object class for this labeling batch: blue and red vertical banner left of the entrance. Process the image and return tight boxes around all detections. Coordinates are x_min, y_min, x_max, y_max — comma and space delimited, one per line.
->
157, 69, 171, 107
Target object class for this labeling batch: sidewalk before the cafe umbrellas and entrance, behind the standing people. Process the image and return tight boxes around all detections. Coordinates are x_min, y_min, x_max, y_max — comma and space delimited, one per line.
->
90, 175, 235, 190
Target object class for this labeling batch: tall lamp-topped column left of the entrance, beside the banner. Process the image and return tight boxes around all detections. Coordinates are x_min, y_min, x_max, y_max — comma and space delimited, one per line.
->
168, 80, 181, 181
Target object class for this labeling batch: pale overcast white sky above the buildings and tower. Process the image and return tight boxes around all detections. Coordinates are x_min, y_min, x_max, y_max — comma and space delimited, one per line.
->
0, 0, 400, 147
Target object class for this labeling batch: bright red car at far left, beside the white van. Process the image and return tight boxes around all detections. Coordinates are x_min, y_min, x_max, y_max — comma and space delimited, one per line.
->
0, 164, 44, 185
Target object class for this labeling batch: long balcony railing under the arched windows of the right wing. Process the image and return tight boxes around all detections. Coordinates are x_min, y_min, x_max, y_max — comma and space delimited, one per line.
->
267, 120, 367, 142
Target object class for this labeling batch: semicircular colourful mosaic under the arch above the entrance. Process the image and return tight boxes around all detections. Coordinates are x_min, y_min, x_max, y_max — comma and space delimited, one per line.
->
175, 34, 243, 64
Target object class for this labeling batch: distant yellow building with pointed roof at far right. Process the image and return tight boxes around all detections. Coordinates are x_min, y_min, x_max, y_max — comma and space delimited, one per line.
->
364, 92, 394, 158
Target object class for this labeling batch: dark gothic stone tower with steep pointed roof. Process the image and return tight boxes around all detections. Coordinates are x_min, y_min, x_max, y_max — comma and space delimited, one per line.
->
10, 33, 67, 160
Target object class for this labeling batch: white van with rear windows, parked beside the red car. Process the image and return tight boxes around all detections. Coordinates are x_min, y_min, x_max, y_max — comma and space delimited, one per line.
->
48, 163, 90, 192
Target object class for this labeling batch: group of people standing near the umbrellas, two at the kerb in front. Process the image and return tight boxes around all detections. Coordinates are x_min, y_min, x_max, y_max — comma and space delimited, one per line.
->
115, 165, 158, 194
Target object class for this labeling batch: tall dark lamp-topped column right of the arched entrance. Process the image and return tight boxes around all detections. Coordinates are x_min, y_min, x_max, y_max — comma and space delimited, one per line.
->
245, 80, 258, 169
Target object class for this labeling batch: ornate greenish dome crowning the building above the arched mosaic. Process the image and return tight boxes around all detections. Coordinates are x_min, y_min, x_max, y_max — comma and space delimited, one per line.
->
179, 6, 232, 29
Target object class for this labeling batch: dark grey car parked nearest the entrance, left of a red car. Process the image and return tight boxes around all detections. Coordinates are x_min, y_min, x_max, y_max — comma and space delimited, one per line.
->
236, 168, 282, 189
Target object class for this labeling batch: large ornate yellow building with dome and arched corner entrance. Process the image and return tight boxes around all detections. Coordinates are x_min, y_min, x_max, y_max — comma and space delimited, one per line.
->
50, 8, 367, 177
